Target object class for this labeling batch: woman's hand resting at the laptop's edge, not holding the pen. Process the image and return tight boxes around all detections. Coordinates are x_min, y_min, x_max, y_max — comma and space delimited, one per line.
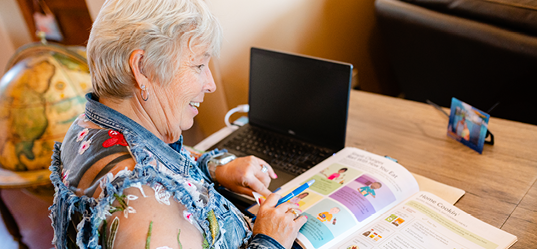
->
215, 156, 278, 197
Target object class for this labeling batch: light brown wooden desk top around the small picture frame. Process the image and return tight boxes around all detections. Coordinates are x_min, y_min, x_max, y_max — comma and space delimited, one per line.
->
346, 91, 537, 249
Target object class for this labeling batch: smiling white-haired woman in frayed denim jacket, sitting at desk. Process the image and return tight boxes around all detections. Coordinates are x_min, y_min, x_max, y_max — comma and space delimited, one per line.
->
51, 0, 307, 248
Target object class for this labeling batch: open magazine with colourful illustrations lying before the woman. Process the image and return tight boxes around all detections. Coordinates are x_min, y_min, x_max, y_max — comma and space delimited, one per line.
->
248, 148, 517, 249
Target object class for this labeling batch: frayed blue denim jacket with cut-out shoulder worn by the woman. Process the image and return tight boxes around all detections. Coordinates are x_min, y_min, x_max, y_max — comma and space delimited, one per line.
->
50, 93, 283, 249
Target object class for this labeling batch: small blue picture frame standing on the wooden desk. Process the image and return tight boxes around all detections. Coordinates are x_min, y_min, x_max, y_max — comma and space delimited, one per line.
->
447, 98, 490, 154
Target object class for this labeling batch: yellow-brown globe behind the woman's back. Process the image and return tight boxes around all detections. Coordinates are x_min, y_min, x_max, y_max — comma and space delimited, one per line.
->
0, 43, 91, 171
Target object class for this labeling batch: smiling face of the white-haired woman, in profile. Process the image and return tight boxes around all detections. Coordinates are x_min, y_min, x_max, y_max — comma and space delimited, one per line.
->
152, 46, 216, 142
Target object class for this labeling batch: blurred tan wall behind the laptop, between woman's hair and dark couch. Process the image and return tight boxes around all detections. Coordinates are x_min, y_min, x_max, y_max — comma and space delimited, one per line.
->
207, 0, 396, 110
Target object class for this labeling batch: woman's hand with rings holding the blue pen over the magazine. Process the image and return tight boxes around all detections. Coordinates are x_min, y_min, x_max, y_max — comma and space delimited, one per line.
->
253, 194, 308, 248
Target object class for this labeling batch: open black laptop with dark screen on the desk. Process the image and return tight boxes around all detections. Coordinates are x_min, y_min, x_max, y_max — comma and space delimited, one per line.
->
211, 48, 352, 195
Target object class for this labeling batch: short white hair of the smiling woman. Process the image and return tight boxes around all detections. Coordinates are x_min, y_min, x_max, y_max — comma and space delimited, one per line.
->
87, 0, 222, 98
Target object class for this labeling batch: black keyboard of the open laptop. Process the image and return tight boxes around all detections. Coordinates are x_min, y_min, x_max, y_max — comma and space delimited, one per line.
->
224, 126, 333, 176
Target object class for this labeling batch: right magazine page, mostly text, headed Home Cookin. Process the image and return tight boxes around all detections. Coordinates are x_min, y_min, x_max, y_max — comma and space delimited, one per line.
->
333, 191, 517, 249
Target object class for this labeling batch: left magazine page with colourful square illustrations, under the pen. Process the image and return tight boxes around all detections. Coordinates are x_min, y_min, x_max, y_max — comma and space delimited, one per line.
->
266, 148, 419, 249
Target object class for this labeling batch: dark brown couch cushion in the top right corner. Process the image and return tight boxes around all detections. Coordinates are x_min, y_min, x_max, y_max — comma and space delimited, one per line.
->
402, 0, 537, 35
